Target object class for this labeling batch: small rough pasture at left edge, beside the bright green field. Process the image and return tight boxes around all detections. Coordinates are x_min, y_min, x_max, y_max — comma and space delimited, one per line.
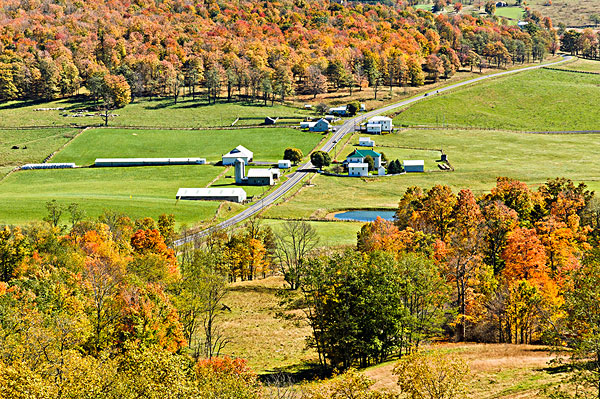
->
0, 129, 77, 177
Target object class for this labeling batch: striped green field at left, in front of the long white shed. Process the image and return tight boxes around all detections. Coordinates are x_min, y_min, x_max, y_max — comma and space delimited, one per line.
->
0, 166, 220, 225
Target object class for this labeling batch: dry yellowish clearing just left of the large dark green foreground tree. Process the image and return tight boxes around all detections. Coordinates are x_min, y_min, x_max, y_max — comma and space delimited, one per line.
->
220, 277, 317, 374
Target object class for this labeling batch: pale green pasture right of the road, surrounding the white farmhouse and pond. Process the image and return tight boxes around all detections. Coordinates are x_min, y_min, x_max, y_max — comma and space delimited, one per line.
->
265, 130, 600, 218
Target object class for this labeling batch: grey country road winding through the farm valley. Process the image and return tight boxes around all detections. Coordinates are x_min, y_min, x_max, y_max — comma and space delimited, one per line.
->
174, 56, 572, 246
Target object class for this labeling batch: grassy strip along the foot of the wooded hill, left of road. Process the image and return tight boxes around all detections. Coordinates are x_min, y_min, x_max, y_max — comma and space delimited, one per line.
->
0, 96, 308, 127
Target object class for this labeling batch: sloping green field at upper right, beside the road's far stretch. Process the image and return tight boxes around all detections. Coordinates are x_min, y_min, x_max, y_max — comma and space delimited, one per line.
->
394, 70, 600, 131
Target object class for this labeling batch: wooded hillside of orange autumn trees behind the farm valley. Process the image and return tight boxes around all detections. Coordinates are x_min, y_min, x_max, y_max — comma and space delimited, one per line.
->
0, 0, 557, 101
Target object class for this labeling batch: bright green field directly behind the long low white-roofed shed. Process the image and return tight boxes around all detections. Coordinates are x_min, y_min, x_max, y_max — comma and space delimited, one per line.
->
53, 128, 322, 165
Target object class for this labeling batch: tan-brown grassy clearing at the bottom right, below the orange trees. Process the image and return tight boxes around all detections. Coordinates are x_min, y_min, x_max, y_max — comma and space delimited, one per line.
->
364, 343, 565, 399
